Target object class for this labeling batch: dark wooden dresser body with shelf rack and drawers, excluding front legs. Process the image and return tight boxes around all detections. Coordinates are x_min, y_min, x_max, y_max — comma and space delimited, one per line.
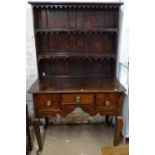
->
29, 2, 125, 150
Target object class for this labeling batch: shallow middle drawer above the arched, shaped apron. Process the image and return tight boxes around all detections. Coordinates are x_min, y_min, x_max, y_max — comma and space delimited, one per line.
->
62, 94, 95, 105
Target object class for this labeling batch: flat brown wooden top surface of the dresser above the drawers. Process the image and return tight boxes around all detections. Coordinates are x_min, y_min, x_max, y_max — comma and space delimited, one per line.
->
28, 77, 125, 93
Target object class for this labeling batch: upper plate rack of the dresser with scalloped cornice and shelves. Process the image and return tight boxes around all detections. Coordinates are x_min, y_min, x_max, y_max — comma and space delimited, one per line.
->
30, 2, 122, 80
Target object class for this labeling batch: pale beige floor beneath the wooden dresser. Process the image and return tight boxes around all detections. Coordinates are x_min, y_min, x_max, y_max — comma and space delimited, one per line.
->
29, 123, 126, 155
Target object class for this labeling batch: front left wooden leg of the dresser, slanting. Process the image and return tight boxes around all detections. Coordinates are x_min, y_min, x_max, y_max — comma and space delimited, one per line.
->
33, 119, 42, 151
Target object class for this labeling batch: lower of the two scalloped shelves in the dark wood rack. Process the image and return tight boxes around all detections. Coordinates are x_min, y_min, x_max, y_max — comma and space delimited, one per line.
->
38, 52, 116, 61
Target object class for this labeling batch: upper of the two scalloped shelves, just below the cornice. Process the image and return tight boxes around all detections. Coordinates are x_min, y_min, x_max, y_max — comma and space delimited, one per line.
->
35, 28, 118, 34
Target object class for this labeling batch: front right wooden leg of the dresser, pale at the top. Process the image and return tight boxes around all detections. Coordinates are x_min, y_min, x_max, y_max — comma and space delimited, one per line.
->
113, 116, 123, 146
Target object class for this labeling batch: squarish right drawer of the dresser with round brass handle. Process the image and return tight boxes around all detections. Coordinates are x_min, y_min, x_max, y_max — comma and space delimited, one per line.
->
96, 93, 121, 111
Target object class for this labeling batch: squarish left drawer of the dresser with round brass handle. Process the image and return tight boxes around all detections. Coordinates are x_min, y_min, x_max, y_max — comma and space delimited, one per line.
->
35, 94, 60, 111
